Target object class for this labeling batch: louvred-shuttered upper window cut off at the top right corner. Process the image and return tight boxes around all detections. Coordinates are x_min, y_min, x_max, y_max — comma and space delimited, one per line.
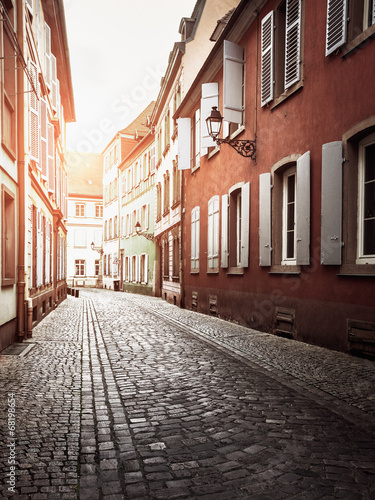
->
326, 0, 375, 56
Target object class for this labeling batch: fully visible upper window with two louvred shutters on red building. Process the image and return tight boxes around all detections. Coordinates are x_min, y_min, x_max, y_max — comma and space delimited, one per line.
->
261, 0, 302, 106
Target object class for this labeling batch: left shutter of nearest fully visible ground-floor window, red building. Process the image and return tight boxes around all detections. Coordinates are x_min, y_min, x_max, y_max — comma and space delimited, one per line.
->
259, 173, 272, 266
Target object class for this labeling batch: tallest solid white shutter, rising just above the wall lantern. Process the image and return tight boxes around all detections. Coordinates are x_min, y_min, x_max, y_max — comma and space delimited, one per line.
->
223, 40, 244, 125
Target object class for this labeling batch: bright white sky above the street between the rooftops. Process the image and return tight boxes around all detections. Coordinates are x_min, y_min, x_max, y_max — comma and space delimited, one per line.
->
64, 0, 196, 153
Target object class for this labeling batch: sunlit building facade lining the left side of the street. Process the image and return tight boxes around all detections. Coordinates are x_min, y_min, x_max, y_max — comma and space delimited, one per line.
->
0, 0, 75, 348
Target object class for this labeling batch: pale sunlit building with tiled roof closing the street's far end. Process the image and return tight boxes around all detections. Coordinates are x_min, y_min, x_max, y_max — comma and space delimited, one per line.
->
66, 152, 103, 288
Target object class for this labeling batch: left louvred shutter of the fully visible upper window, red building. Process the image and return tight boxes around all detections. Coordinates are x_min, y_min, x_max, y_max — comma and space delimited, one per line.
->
261, 10, 274, 106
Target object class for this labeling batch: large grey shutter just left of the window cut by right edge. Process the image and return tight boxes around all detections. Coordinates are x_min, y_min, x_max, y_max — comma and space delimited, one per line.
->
320, 141, 342, 265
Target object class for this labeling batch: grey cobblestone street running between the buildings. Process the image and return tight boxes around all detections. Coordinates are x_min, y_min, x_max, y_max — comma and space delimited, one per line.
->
0, 290, 375, 500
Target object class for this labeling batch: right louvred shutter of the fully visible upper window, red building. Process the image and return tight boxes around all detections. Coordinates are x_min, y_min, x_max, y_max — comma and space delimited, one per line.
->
285, 0, 301, 89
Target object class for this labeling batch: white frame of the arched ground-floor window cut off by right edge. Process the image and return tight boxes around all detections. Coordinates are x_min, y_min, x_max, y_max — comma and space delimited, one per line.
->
356, 133, 375, 264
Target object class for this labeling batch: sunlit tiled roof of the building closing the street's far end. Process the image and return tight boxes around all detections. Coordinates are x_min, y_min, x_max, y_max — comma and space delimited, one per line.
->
65, 151, 103, 198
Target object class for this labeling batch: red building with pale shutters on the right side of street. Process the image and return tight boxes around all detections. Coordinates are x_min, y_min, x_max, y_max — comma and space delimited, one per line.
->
175, 0, 375, 354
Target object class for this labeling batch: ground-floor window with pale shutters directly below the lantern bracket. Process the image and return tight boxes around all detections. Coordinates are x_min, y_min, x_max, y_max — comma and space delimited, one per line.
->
221, 183, 250, 273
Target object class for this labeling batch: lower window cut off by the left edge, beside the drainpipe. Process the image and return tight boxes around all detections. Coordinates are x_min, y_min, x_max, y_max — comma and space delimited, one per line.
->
1, 184, 16, 286
